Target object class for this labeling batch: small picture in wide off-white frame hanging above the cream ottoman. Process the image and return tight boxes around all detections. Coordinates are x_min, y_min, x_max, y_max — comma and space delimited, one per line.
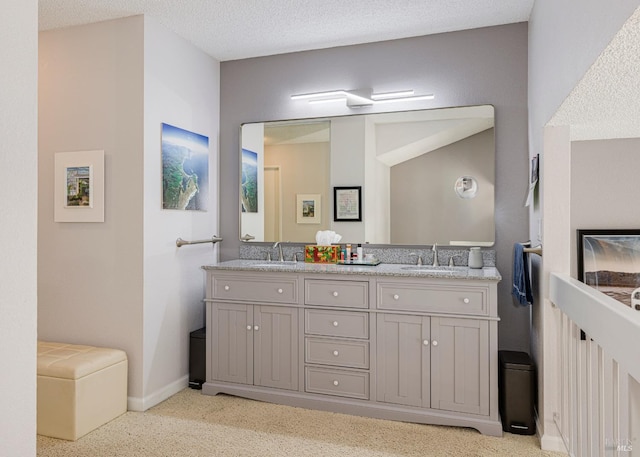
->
53, 150, 104, 222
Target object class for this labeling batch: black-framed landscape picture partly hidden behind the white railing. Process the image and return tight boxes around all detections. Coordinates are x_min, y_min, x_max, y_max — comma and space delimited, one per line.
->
577, 229, 640, 310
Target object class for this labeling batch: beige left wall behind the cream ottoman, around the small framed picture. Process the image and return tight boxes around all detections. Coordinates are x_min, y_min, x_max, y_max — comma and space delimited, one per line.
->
38, 16, 144, 397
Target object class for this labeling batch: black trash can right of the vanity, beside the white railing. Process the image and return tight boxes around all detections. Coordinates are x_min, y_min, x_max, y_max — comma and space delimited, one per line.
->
498, 351, 536, 435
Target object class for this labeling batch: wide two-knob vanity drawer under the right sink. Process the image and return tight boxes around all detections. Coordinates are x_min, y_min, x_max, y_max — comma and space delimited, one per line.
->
378, 282, 488, 315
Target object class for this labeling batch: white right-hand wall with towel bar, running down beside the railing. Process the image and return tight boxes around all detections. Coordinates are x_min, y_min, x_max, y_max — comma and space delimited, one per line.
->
528, 0, 640, 449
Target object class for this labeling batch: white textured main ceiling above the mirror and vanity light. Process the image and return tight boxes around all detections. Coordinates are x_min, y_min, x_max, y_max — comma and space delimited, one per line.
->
39, 0, 534, 61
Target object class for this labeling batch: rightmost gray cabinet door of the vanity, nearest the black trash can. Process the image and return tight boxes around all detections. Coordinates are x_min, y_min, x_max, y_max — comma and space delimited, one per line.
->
431, 317, 489, 415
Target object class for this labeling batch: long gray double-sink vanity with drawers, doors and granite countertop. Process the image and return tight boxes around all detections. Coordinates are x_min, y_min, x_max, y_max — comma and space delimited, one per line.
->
202, 260, 502, 436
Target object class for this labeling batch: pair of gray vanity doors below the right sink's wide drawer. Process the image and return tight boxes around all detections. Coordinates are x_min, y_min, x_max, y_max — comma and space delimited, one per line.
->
377, 314, 489, 415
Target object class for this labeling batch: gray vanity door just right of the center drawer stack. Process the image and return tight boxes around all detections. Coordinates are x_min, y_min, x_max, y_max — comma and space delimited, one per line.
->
376, 314, 430, 408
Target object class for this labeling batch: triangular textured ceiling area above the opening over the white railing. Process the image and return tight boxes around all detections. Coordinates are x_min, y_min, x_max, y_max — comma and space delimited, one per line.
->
549, 8, 640, 140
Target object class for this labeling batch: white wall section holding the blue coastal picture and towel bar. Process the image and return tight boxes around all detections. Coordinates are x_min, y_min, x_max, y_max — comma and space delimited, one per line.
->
141, 17, 220, 409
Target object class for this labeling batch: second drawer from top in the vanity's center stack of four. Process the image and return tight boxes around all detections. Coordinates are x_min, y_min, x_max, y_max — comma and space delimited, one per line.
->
304, 309, 369, 339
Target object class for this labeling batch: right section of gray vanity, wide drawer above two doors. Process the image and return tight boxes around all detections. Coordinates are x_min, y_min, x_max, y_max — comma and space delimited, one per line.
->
376, 280, 495, 416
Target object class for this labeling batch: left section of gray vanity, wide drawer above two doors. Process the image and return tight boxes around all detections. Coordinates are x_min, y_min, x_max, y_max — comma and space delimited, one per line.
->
207, 275, 299, 390
